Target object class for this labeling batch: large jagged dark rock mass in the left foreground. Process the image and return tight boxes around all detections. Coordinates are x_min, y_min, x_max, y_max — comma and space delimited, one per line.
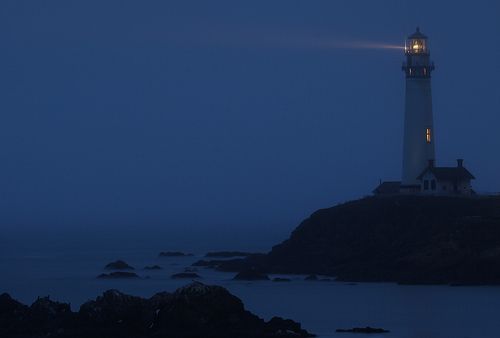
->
0, 283, 311, 338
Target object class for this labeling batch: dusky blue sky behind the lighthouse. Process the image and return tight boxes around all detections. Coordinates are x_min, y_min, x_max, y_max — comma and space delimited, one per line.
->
0, 0, 500, 244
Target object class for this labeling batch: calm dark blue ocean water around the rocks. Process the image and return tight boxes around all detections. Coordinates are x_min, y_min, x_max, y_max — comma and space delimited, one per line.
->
0, 243, 500, 338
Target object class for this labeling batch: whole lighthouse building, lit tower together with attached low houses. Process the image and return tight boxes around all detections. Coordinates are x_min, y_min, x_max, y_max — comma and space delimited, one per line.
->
373, 27, 475, 196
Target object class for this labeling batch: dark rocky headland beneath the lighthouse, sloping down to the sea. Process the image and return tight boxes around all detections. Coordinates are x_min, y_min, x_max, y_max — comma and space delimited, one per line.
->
210, 196, 500, 285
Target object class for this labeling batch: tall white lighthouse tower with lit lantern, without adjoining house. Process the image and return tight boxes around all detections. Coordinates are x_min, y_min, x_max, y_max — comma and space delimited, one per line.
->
401, 27, 435, 192
